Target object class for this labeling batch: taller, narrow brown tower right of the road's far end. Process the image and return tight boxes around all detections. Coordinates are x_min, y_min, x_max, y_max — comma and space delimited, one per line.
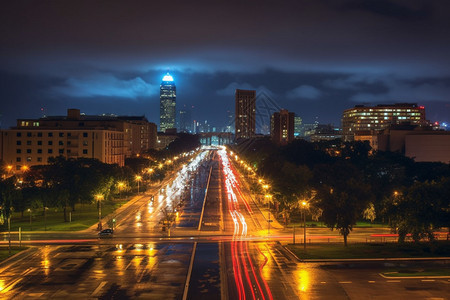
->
235, 89, 256, 139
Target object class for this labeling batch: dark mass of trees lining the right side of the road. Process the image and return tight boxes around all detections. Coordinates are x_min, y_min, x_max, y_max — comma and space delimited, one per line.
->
231, 138, 450, 244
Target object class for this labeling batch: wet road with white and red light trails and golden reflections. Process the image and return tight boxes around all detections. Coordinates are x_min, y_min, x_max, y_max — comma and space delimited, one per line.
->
0, 151, 450, 299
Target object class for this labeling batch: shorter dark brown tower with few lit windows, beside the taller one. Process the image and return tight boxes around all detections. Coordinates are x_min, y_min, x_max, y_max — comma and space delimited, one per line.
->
270, 109, 295, 145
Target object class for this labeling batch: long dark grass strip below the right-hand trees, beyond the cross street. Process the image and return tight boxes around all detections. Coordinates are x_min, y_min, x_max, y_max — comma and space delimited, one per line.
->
287, 241, 450, 259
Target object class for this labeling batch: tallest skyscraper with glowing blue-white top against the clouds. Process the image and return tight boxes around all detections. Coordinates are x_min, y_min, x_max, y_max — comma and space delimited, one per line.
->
159, 73, 177, 132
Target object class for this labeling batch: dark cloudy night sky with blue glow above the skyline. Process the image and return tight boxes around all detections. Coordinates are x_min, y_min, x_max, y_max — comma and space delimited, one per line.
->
0, 0, 450, 128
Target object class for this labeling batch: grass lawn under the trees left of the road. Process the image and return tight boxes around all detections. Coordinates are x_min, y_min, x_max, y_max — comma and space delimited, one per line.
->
0, 200, 127, 231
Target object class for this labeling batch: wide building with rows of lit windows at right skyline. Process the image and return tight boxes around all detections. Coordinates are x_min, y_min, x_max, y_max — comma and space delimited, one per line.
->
342, 103, 428, 141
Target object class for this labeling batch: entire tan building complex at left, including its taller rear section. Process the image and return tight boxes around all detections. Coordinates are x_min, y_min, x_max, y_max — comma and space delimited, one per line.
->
0, 109, 156, 170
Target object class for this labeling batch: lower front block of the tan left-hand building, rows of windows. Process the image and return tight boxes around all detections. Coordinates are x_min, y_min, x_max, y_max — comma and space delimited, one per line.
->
1, 127, 125, 171
